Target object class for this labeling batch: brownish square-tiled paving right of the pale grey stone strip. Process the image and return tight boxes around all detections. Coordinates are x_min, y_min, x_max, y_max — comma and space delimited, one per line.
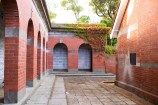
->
64, 76, 152, 105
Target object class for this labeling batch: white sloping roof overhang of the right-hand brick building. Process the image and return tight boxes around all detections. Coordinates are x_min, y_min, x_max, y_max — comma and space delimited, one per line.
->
110, 0, 128, 38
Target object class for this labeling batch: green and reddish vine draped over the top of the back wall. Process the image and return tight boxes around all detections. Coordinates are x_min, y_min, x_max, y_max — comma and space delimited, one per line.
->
54, 24, 110, 52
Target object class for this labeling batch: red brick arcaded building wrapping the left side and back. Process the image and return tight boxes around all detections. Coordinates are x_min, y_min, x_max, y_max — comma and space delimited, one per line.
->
0, 0, 105, 104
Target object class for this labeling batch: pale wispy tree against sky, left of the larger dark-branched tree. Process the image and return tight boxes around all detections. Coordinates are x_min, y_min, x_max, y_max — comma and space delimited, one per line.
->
61, 0, 83, 21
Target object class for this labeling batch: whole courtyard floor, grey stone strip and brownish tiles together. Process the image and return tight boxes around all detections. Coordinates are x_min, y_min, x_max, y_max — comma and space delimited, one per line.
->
24, 75, 152, 105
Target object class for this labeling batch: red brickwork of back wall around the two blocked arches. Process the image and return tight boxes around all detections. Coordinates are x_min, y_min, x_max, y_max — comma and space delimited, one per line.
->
47, 36, 105, 72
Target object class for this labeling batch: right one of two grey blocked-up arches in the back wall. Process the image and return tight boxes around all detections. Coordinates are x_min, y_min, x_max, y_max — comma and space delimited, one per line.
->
78, 44, 92, 71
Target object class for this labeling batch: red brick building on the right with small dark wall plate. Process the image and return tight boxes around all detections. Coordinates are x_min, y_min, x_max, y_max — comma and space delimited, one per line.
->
111, 0, 158, 103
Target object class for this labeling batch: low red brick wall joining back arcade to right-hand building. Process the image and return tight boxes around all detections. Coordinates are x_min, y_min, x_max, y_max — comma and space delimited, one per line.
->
105, 55, 117, 74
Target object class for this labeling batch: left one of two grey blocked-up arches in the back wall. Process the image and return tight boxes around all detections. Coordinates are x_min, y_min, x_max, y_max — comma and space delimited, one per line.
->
53, 43, 68, 71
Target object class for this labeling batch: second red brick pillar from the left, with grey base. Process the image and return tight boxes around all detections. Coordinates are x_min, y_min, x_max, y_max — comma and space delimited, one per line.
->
26, 20, 37, 87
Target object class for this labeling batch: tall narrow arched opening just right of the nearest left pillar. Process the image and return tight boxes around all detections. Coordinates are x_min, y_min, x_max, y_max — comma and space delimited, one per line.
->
26, 20, 34, 87
